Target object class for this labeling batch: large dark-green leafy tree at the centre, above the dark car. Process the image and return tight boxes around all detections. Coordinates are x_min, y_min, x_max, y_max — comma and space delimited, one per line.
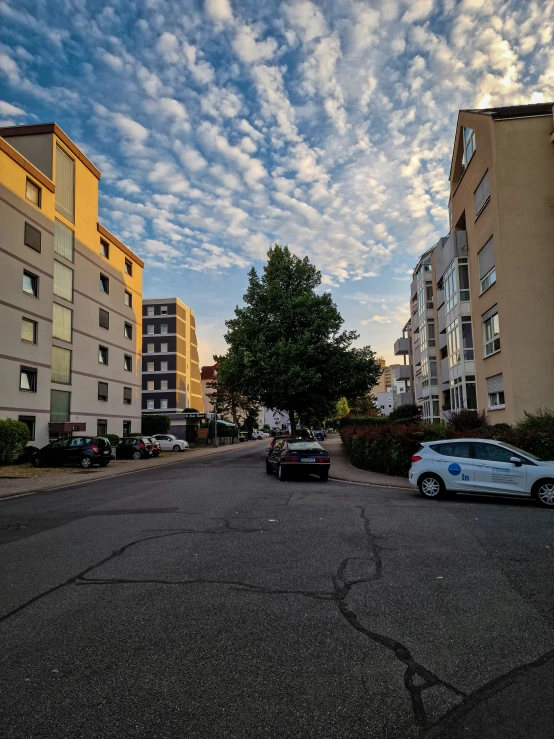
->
218, 249, 380, 433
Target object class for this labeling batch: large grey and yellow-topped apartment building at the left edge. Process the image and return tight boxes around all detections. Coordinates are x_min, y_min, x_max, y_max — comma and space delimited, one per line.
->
0, 123, 144, 446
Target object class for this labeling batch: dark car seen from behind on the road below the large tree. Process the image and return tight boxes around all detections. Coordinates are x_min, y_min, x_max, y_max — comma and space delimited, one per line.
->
265, 438, 331, 482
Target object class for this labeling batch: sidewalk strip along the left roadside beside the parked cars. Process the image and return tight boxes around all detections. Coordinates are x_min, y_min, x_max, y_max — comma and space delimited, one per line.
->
0, 439, 268, 500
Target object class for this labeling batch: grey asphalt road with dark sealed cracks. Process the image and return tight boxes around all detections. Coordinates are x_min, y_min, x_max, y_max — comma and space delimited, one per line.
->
0, 445, 554, 739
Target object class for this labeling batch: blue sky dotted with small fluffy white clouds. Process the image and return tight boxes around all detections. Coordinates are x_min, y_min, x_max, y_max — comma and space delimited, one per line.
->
0, 0, 554, 364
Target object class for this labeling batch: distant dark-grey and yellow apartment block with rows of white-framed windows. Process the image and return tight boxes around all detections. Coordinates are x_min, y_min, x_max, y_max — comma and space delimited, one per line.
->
142, 298, 204, 413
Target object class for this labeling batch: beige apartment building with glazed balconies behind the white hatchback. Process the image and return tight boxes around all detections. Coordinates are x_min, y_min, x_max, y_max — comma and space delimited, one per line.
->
398, 103, 554, 423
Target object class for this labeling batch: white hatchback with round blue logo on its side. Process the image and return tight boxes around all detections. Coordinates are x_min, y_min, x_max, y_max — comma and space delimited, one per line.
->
409, 439, 554, 508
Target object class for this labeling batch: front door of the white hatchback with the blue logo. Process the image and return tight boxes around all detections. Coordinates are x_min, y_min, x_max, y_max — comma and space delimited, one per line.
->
473, 441, 527, 494
